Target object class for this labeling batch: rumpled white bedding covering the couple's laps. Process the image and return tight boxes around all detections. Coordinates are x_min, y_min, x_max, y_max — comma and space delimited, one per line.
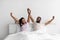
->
4, 31, 60, 40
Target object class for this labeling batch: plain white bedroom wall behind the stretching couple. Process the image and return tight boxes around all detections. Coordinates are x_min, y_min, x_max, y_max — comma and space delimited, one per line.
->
0, 0, 60, 40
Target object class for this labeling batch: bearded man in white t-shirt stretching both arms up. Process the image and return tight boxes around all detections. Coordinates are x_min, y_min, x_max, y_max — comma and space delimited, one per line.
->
29, 9, 55, 30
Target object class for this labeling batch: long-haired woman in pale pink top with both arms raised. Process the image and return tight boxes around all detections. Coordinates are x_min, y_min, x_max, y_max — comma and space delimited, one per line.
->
10, 8, 30, 31
